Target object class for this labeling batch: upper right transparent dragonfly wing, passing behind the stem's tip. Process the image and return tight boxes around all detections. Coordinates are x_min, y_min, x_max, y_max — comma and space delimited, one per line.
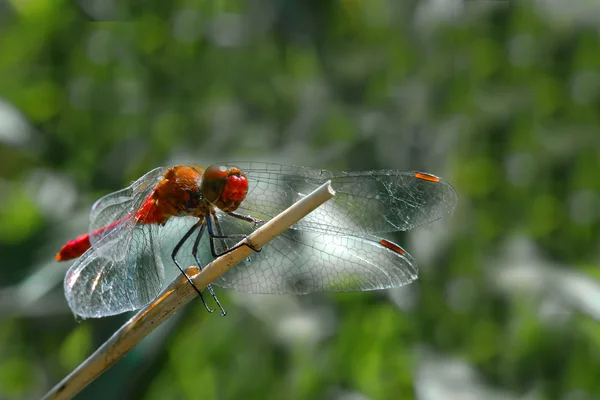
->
232, 162, 457, 236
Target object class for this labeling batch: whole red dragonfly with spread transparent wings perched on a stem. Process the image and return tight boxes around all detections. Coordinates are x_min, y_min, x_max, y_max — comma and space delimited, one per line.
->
56, 162, 457, 318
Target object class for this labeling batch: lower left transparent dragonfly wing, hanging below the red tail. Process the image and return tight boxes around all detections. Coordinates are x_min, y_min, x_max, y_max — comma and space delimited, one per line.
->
64, 225, 164, 318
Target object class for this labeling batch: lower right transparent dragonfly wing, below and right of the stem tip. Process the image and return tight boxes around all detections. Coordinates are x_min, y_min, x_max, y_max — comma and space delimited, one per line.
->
193, 214, 418, 294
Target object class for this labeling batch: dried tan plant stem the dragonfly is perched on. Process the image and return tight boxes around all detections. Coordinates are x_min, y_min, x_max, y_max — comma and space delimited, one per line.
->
44, 181, 335, 399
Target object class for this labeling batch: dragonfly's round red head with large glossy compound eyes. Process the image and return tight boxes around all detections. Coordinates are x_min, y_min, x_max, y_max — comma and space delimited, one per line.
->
201, 164, 248, 212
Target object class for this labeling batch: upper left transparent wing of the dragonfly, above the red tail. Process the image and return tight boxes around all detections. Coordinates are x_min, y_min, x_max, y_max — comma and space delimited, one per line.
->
89, 167, 167, 245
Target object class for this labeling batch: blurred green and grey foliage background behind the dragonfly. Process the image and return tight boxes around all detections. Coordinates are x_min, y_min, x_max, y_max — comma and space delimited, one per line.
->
0, 0, 600, 400
